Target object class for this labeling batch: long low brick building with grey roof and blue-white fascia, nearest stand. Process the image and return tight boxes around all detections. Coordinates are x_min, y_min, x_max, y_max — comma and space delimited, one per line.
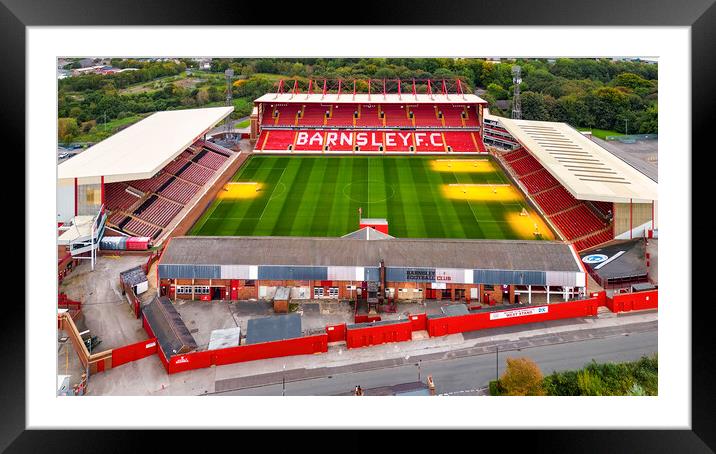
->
158, 231, 586, 303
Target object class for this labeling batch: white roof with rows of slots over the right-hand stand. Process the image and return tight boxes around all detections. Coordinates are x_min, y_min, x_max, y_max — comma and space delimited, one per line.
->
493, 117, 658, 203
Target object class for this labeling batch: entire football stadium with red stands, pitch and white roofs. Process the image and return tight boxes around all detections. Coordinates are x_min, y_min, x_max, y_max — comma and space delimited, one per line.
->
57, 75, 658, 380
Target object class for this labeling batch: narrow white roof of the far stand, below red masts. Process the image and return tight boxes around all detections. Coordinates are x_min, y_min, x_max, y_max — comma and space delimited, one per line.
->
255, 90, 487, 104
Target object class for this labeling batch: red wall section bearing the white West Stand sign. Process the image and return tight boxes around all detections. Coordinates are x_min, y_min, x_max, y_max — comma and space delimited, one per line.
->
427, 298, 598, 337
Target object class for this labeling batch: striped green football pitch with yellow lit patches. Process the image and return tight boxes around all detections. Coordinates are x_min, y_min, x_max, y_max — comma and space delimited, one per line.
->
189, 155, 553, 239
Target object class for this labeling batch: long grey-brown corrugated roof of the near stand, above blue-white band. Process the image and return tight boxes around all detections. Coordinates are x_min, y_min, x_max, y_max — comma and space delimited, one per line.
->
161, 236, 582, 272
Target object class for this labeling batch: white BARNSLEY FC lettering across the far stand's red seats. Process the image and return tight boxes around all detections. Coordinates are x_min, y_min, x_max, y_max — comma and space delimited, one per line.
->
296, 131, 444, 150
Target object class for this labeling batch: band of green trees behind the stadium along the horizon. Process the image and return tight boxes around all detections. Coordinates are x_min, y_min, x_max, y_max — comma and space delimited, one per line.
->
58, 58, 658, 144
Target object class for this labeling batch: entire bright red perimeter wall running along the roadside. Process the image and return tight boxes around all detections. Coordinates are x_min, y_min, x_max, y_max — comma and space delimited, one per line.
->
88, 290, 658, 374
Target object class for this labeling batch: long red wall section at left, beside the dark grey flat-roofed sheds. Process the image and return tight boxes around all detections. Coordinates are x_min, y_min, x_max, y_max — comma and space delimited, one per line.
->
160, 334, 328, 374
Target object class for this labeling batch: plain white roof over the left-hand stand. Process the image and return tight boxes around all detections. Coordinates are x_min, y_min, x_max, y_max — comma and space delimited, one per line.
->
57, 107, 234, 184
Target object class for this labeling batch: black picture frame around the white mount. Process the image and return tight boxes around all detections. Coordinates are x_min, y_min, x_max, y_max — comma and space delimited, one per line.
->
0, 0, 716, 453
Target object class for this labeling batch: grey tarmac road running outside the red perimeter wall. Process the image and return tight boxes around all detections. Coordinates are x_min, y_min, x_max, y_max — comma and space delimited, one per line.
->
213, 330, 658, 396
